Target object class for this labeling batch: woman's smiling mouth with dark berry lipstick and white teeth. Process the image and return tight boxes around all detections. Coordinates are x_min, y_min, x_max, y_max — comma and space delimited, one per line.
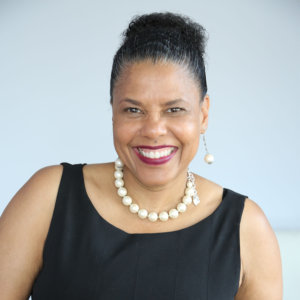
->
133, 145, 177, 165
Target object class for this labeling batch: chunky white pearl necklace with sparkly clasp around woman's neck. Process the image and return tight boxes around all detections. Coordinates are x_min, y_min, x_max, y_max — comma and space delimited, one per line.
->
114, 158, 200, 222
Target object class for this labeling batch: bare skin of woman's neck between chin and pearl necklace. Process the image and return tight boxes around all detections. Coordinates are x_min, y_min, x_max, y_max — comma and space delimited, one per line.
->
123, 167, 187, 212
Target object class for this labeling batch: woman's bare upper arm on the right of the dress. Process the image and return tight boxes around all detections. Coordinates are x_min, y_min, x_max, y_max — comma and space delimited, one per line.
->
235, 199, 283, 300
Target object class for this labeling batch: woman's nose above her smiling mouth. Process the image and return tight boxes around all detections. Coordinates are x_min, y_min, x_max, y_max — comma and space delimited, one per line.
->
141, 113, 167, 139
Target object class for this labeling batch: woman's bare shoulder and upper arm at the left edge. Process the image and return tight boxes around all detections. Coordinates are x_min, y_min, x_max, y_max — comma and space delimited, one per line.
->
0, 165, 63, 299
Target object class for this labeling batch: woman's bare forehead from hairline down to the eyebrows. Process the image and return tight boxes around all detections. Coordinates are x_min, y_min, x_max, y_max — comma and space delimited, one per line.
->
113, 60, 200, 103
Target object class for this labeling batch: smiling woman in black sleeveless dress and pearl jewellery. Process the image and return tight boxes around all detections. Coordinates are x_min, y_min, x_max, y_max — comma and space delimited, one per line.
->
0, 13, 282, 300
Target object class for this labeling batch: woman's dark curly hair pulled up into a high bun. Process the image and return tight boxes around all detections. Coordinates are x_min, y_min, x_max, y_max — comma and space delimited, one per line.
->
110, 12, 207, 104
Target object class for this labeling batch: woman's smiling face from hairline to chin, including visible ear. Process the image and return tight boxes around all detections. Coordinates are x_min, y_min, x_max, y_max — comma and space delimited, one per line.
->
112, 60, 209, 186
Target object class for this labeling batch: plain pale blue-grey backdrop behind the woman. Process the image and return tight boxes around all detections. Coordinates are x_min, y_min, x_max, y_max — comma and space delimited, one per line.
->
0, 0, 300, 229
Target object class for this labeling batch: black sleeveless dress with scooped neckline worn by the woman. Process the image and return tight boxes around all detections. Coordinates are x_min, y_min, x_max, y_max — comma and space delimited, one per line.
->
31, 162, 247, 300
